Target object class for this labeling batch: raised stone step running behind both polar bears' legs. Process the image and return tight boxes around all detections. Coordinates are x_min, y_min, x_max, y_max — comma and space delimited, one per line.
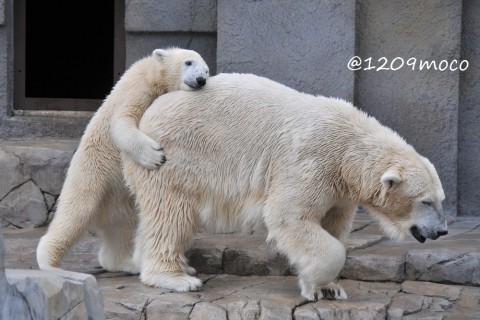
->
3, 214, 480, 286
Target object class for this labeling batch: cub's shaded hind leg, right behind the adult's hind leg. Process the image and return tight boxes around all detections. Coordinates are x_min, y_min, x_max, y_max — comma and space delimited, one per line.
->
97, 190, 139, 273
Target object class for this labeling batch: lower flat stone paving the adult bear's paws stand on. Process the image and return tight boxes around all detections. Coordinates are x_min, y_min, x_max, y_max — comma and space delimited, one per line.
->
97, 274, 480, 320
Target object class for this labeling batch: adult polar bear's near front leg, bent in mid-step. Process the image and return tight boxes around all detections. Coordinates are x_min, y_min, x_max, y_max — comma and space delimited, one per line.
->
265, 205, 347, 301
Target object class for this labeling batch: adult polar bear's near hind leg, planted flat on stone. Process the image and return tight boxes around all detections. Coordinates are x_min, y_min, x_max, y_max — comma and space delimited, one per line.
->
134, 191, 202, 292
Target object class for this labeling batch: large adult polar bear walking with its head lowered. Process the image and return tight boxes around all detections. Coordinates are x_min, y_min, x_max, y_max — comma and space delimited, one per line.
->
124, 74, 447, 300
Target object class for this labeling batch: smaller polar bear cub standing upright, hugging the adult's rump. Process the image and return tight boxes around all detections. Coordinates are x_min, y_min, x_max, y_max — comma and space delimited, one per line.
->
37, 48, 209, 272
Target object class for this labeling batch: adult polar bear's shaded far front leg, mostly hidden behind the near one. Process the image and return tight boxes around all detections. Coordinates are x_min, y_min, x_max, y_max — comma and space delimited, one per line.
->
320, 204, 357, 243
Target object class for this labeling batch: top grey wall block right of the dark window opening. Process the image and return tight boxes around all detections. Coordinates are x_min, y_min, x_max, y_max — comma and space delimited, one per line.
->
125, 0, 217, 32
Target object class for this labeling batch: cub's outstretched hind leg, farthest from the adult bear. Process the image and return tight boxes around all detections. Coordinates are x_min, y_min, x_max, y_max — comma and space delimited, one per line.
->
37, 160, 109, 270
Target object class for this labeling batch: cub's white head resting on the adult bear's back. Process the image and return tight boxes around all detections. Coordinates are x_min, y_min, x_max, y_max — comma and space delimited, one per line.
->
152, 48, 210, 91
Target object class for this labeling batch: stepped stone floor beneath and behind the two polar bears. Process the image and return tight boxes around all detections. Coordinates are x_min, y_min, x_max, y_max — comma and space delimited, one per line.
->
2, 215, 480, 320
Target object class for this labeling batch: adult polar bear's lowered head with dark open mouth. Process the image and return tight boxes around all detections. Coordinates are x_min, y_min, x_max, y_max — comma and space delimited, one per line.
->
365, 155, 448, 243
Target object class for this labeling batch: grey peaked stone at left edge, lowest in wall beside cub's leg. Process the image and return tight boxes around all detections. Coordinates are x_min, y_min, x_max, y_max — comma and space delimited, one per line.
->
0, 181, 48, 228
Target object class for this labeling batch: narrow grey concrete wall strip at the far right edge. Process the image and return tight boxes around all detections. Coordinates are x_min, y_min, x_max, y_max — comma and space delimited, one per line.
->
458, 0, 480, 215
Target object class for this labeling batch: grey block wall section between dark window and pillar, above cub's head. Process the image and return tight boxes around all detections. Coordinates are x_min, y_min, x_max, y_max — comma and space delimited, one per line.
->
125, 0, 217, 74
